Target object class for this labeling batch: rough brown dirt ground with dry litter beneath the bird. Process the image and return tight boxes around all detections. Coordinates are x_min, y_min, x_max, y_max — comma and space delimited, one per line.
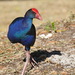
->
0, 15, 75, 75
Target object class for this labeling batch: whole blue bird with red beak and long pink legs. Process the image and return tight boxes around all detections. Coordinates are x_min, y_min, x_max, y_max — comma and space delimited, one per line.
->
7, 8, 42, 75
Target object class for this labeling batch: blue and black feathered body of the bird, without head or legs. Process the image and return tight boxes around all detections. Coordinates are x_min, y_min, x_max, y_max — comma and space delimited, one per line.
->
7, 9, 36, 50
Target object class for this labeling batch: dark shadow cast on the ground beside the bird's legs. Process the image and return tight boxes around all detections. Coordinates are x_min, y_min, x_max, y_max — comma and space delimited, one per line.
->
23, 50, 62, 63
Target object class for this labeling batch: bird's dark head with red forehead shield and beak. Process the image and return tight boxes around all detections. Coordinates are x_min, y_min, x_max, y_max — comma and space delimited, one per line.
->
25, 8, 42, 20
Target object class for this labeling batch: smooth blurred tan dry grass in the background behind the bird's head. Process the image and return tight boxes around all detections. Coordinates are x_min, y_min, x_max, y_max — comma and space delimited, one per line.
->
0, 0, 75, 32
